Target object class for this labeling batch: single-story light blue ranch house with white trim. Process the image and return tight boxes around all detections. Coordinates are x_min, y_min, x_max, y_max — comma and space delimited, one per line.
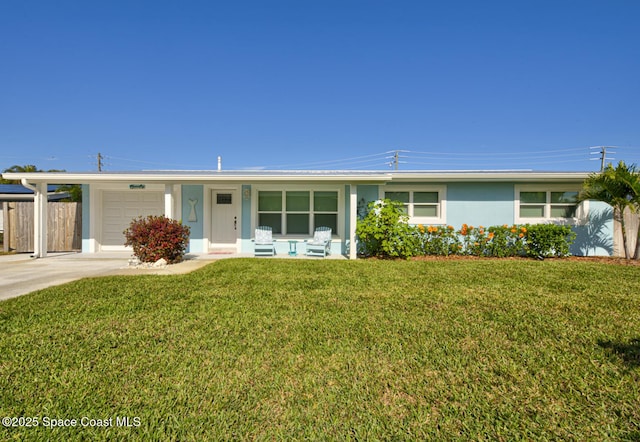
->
3, 170, 614, 258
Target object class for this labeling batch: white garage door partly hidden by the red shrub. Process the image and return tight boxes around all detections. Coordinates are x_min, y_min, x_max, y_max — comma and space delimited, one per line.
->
101, 191, 164, 250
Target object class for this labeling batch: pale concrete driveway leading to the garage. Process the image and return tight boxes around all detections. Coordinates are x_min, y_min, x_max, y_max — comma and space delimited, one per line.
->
0, 252, 219, 300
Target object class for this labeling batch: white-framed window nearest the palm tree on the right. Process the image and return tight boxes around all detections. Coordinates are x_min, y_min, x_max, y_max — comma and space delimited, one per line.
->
516, 186, 586, 223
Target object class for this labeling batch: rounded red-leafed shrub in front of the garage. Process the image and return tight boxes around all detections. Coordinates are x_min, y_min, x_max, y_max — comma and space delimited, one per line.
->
124, 215, 190, 263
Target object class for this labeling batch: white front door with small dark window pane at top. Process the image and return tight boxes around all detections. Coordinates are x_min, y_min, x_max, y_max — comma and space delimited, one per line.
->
211, 189, 240, 247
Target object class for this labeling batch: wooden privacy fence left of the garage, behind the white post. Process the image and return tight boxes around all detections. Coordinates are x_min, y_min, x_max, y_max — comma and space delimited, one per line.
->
2, 201, 82, 253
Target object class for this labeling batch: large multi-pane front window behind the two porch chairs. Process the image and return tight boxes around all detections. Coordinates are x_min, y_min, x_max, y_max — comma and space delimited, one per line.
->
258, 190, 338, 236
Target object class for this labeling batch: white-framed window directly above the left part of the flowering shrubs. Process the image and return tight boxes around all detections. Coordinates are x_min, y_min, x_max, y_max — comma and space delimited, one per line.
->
383, 186, 446, 224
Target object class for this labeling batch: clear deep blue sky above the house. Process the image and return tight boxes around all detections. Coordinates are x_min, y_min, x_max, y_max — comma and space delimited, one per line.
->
0, 0, 640, 171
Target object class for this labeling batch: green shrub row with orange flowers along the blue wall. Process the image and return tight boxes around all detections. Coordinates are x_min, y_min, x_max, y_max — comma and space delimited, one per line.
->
356, 200, 576, 258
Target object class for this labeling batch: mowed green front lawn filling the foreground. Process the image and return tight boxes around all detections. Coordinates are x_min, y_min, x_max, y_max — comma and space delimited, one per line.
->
0, 259, 640, 441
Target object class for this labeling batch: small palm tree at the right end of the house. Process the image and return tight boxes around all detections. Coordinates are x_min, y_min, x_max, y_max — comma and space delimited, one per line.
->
578, 161, 640, 259
